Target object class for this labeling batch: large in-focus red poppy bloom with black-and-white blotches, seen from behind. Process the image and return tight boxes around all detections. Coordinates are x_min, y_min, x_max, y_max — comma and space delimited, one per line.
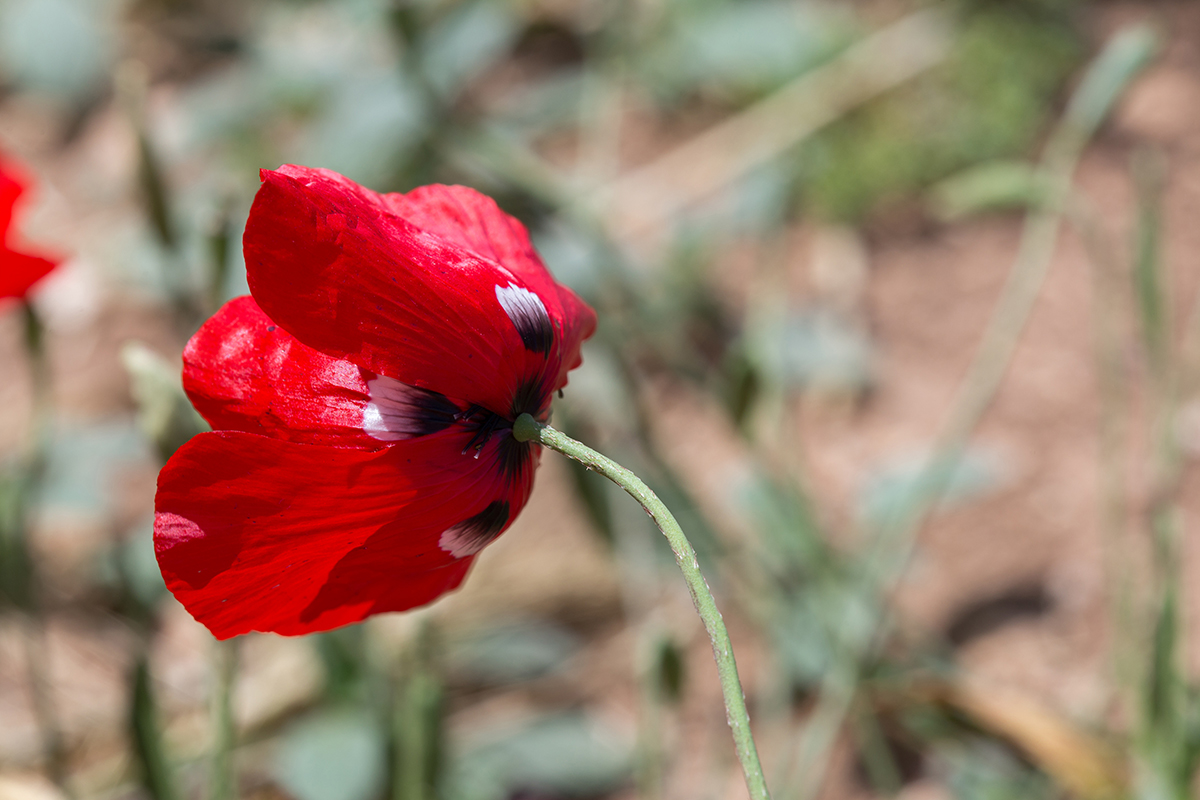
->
155, 167, 595, 639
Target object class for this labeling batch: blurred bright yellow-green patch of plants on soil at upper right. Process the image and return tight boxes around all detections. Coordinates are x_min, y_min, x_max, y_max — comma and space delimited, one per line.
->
797, 2, 1084, 222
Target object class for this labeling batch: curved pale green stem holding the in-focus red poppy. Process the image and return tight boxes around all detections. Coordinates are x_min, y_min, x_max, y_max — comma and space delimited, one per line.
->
512, 414, 770, 800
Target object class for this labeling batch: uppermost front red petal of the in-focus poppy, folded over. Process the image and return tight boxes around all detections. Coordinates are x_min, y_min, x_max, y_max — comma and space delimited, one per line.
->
244, 167, 594, 415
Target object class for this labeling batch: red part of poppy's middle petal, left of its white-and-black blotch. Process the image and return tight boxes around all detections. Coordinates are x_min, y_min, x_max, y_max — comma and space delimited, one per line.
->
184, 296, 384, 450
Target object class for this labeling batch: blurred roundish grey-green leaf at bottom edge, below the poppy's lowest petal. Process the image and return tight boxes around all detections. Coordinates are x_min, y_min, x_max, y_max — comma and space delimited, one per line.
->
271, 709, 385, 800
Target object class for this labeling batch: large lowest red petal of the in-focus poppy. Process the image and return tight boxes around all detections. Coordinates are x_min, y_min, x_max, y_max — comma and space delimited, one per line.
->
155, 431, 534, 639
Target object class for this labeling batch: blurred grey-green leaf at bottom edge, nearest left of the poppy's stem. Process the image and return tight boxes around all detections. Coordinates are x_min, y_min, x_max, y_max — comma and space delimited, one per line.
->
451, 714, 632, 800
